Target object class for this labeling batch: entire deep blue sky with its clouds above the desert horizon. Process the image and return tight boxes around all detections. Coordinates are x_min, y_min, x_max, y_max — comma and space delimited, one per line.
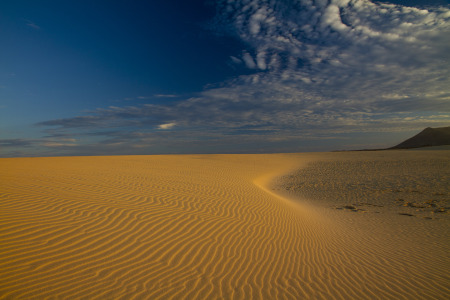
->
0, 0, 450, 157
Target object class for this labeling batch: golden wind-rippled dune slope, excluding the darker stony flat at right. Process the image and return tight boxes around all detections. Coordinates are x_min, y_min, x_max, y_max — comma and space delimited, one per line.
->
0, 154, 449, 299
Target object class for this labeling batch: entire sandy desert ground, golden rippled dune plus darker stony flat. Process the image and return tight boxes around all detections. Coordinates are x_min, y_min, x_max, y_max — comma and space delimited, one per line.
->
0, 150, 450, 299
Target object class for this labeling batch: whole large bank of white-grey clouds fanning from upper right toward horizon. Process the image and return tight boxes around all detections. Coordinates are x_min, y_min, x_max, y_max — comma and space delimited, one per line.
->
7, 0, 450, 157
